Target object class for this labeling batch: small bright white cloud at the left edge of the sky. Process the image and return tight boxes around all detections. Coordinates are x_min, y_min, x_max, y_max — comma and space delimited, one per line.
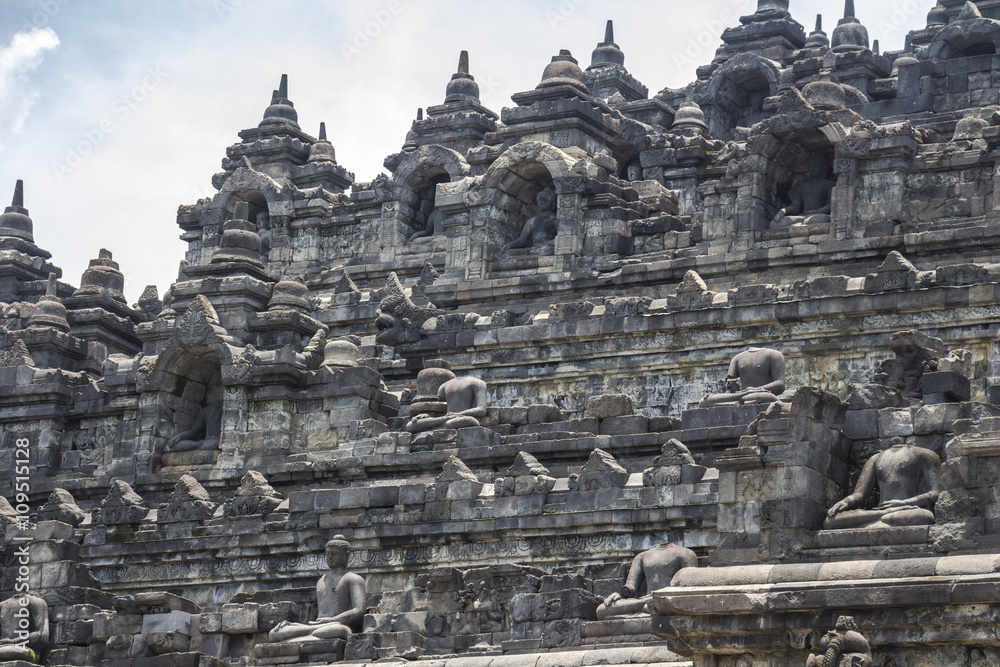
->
0, 28, 59, 150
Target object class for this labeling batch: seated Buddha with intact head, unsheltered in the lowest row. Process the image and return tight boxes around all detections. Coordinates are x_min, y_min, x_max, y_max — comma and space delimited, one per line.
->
268, 535, 367, 642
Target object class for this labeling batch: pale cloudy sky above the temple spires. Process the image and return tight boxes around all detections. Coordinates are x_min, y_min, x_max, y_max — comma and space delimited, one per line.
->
0, 0, 935, 303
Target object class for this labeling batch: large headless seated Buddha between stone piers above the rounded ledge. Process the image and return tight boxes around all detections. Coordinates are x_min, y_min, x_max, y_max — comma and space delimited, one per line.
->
823, 438, 942, 529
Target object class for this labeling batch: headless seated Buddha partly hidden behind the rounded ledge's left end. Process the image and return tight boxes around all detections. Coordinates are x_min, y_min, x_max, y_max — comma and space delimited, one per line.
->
597, 542, 698, 620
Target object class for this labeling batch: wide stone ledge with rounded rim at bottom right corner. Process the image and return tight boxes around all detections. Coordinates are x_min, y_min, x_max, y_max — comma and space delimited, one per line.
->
649, 554, 1000, 667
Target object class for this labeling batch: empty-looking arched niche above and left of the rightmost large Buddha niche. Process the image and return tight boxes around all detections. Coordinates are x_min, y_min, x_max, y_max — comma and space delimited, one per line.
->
698, 54, 778, 141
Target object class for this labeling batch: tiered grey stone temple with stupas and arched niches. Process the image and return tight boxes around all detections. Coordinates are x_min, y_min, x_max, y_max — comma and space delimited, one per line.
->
7, 0, 1000, 667
